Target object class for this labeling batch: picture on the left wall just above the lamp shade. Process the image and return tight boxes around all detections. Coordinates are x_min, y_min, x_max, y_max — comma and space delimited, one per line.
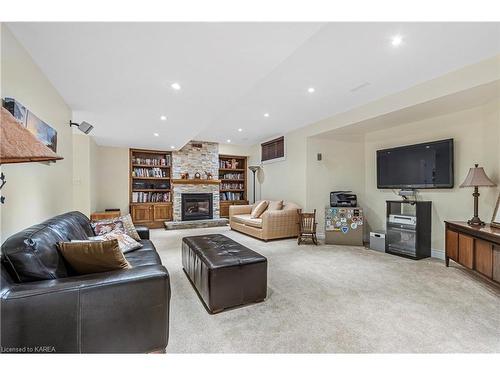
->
4, 98, 57, 152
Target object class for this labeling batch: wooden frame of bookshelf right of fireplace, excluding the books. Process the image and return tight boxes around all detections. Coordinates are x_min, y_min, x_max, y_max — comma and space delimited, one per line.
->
219, 154, 248, 217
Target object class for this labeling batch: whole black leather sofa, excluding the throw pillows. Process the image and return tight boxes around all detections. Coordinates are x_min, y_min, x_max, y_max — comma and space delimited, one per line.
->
0, 212, 170, 353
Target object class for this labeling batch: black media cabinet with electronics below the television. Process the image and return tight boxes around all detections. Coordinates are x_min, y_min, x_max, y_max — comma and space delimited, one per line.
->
385, 200, 432, 259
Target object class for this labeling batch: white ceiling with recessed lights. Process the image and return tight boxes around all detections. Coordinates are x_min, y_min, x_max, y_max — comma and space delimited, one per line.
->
8, 23, 500, 148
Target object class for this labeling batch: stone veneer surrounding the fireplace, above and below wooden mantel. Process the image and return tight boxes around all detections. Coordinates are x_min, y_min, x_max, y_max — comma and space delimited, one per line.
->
172, 141, 220, 221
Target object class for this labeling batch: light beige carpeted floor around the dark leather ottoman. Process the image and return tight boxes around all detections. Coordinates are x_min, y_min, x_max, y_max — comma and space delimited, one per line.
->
152, 227, 500, 353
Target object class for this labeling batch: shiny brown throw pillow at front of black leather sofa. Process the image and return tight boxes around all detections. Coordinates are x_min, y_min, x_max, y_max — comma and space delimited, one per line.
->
57, 240, 132, 275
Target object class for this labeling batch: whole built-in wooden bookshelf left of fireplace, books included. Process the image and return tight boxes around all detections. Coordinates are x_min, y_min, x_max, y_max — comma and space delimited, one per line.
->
129, 149, 172, 227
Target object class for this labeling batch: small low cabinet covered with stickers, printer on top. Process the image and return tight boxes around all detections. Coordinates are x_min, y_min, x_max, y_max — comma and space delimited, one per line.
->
325, 207, 364, 246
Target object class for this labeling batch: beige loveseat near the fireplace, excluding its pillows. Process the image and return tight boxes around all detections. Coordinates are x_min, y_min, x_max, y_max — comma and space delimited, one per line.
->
229, 202, 300, 241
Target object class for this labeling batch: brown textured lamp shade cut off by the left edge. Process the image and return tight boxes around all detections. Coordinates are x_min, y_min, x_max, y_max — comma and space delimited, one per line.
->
0, 108, 62, 164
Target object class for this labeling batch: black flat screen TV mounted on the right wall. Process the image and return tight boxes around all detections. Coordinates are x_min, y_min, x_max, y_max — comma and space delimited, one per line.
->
377, 139, 454, 189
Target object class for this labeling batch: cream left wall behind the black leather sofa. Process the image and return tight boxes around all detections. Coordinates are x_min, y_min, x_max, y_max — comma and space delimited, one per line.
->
1, 24, 73, 241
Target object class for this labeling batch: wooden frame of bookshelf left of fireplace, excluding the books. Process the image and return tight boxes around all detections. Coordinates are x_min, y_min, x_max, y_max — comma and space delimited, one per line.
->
129, 148, 173, 228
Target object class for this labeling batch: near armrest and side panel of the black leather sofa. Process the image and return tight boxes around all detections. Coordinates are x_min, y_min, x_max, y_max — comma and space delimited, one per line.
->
1, 265, 170, 353
